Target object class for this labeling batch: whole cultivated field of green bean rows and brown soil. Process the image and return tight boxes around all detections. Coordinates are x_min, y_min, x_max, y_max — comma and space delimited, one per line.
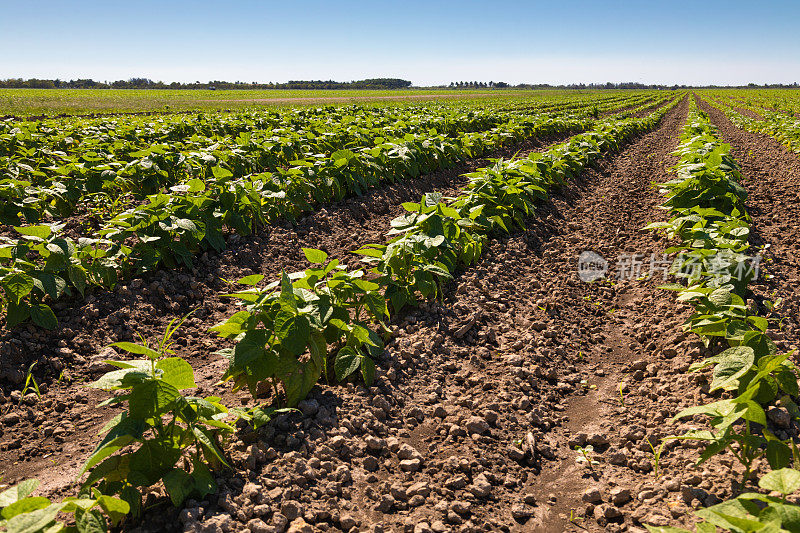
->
0, 90, 800, 533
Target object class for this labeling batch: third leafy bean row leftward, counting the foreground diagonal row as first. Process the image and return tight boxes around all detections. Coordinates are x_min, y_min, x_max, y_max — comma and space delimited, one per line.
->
0, 107, 588, 225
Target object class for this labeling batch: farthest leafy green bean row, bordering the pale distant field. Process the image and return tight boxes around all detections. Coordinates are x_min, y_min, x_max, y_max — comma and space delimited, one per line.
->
0, 91, 649, 162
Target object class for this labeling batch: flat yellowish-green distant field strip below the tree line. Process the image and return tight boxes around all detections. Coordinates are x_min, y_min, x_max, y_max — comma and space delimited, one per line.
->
0, 89, 556, 116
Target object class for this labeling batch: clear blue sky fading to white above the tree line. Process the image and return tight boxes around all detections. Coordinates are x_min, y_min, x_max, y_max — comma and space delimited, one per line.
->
0, 0, 800, 85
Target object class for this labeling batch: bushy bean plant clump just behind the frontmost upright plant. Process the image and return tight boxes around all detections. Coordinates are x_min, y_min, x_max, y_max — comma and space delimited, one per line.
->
211, 249, 389, 407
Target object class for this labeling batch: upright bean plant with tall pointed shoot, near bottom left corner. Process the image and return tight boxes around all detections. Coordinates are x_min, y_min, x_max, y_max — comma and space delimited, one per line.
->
82, 315, 234, 516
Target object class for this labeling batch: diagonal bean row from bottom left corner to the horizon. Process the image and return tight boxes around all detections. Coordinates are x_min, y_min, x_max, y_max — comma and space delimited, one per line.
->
0, 94, 677, 531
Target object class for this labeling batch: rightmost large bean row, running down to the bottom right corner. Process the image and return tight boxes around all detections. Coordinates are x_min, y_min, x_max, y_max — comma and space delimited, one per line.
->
647, 101, 800, 533
